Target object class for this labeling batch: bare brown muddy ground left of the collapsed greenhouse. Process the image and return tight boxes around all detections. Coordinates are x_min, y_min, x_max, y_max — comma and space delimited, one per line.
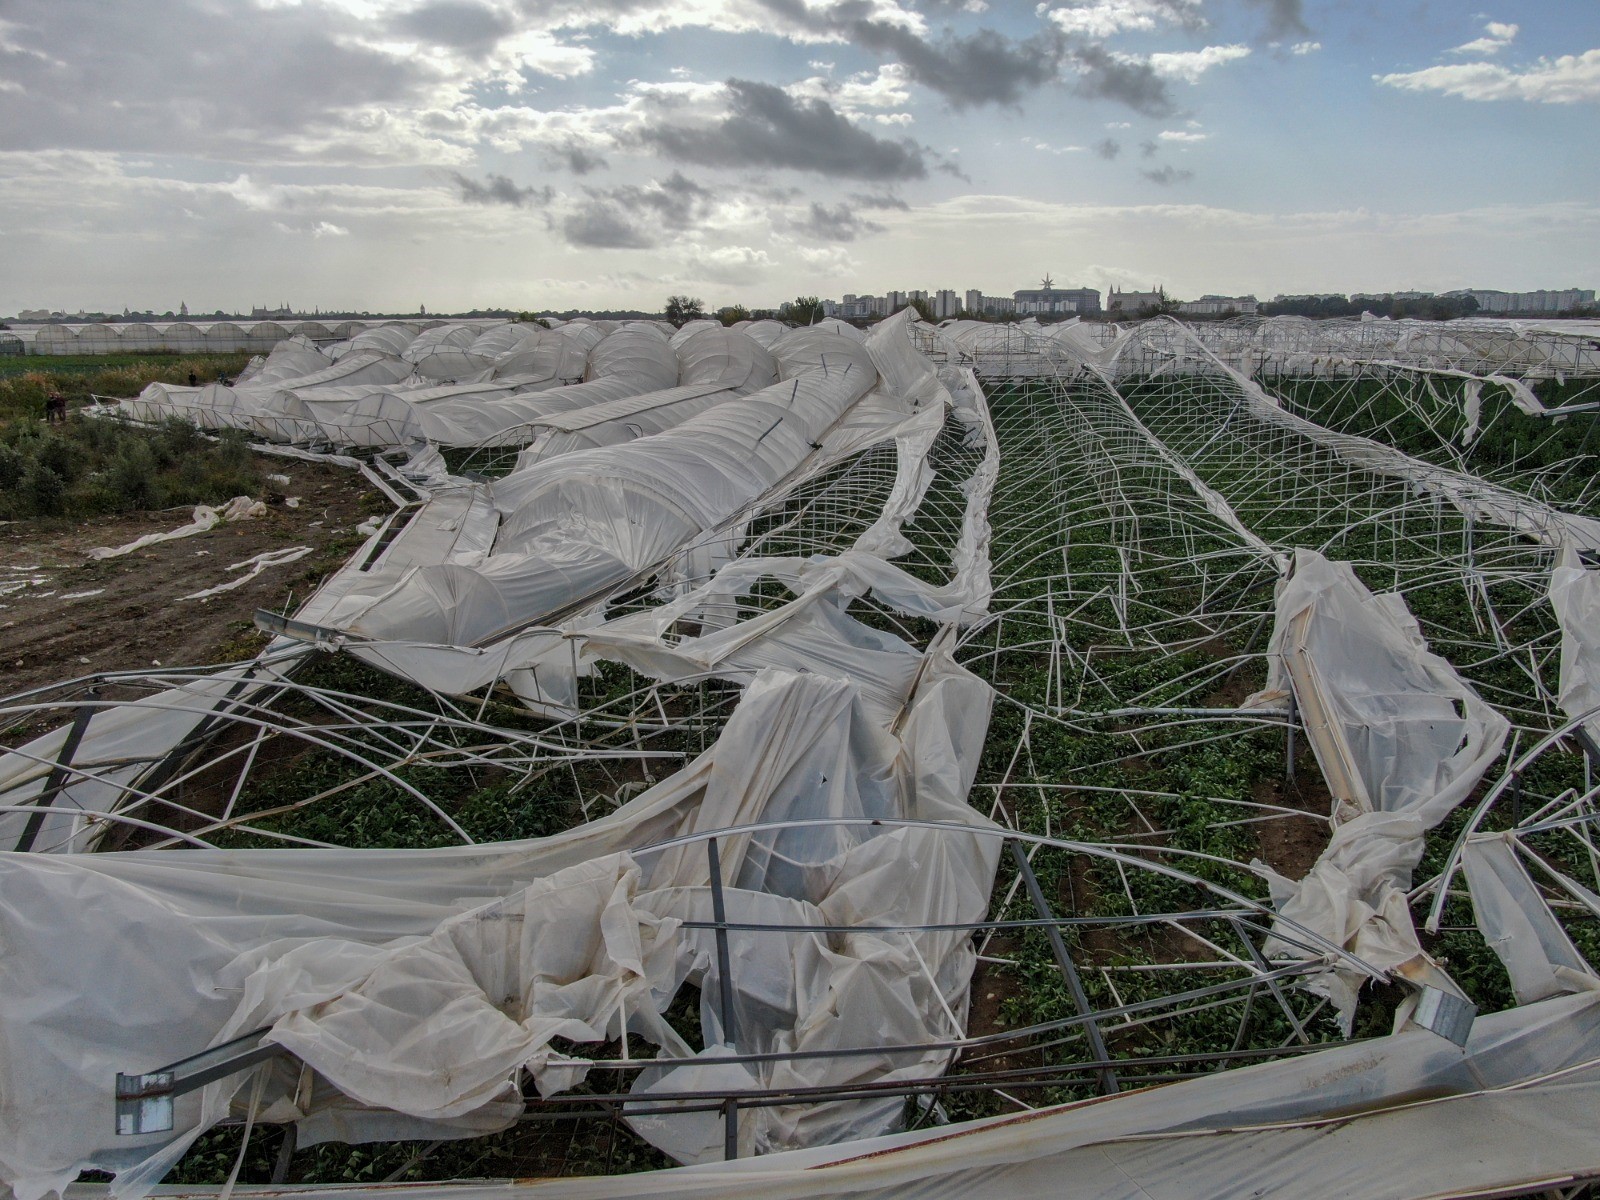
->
0, 458, 380, 694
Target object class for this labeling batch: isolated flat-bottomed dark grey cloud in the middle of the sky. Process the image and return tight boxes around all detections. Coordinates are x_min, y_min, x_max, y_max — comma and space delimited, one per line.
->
632, 78, 928, 182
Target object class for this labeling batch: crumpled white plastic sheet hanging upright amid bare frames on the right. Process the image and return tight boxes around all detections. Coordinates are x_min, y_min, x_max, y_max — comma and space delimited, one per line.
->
1258, 550, 1510, 1032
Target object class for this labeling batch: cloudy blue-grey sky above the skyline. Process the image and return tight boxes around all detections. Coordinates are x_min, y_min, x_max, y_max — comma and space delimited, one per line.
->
0, 0, 1600, 314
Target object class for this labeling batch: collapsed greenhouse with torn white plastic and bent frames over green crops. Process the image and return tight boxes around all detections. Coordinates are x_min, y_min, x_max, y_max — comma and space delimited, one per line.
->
0, 314, 1600, 1200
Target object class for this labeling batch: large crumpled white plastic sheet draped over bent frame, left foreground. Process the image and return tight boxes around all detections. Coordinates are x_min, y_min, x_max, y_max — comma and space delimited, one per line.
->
0, 653, 998, 1200
